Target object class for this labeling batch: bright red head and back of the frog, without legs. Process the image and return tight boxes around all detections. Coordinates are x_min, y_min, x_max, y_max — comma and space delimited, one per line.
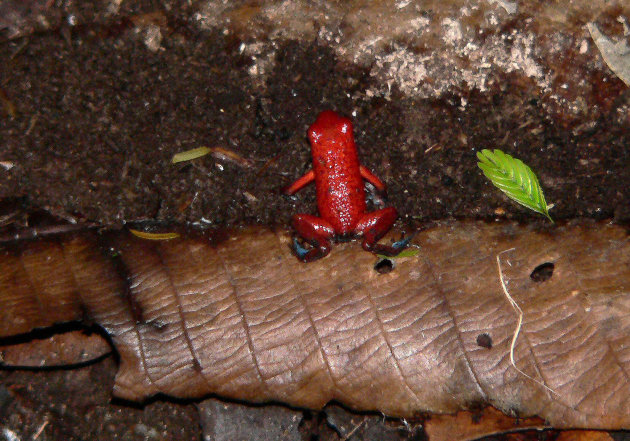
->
308, 110, 366, 234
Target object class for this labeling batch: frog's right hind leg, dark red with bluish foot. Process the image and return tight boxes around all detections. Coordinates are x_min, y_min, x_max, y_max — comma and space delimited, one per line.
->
355, 207, 411, 256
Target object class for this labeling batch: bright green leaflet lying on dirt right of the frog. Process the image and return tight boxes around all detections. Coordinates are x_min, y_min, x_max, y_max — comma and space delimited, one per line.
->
477, 149, 553, 222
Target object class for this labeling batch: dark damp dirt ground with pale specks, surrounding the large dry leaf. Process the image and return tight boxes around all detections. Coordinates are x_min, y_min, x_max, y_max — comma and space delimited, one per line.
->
0, 0, 630, 440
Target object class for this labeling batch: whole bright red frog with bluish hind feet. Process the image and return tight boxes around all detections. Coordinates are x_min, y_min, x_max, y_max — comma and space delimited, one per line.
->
283, 110, 411, 262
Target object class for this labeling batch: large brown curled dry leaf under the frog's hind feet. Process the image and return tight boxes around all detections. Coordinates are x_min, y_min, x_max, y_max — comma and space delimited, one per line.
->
0, 223, 630, 429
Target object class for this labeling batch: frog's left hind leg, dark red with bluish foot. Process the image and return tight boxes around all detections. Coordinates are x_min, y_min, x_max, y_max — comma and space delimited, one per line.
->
292, 214, 335, 262
